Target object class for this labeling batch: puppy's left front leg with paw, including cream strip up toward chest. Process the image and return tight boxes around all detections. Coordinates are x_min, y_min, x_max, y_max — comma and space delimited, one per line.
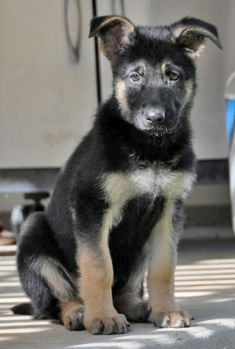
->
77, 201, 129, 334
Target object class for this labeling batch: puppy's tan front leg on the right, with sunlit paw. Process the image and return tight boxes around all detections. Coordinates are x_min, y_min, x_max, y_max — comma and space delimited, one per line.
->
147, 203, 191, 327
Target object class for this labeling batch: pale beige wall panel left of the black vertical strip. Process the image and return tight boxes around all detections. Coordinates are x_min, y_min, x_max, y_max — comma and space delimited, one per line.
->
0, 0, 97, 168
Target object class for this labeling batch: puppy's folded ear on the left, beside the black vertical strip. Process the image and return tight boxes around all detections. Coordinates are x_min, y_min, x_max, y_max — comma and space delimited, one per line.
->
89, 16, 135, 62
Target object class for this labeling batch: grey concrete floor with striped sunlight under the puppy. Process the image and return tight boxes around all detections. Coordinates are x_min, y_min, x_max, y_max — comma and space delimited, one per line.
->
0, 240, 235, 349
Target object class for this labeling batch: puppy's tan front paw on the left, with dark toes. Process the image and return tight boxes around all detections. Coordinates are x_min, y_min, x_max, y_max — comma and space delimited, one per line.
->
84, 313, 130, 334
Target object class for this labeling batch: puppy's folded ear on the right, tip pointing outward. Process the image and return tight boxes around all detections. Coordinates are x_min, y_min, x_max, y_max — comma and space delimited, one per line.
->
172, 17, 222, 59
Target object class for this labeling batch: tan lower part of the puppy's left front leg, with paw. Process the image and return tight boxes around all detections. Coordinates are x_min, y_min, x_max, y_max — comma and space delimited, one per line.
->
79, 246, 128, 334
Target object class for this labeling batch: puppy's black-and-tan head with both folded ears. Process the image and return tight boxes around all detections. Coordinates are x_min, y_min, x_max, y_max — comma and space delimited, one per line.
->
90, 16, 221, 136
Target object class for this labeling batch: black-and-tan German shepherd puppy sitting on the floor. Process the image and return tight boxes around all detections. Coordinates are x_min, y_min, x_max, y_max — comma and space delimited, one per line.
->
14, 16, 221, 334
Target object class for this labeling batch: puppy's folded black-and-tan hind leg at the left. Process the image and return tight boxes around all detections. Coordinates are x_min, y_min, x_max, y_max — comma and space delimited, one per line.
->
17, 209, 83, 330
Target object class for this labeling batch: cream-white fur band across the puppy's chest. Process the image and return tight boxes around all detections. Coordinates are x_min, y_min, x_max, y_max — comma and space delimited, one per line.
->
104, 167, 194, 208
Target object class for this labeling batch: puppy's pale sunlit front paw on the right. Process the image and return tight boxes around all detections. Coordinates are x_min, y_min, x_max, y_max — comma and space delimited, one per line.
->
149, 310, 192, 328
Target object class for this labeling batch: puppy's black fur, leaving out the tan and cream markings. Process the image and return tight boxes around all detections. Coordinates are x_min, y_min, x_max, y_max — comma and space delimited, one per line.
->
13, 17, 221, 332
